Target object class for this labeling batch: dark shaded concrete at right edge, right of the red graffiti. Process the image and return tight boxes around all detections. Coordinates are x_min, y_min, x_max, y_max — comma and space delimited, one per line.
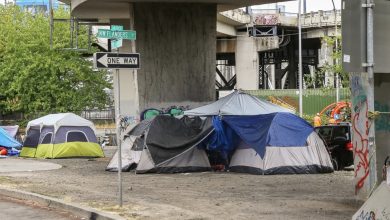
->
374, 73, 390, 182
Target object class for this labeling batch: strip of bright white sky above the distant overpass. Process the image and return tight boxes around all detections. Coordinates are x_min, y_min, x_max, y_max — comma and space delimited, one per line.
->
253, 0, 341, 13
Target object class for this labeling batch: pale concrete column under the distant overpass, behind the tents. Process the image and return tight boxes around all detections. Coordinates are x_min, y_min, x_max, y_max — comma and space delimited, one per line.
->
236, 36, 259, 90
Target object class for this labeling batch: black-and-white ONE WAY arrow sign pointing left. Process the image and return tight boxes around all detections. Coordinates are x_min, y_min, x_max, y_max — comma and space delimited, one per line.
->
93, 53, 140, 69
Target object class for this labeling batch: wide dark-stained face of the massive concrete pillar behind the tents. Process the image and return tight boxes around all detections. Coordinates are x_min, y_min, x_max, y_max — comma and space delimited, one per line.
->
134, 3, 217, 111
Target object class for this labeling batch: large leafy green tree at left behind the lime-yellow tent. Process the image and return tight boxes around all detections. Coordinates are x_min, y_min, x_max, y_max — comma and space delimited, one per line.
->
0, 5, 111, 117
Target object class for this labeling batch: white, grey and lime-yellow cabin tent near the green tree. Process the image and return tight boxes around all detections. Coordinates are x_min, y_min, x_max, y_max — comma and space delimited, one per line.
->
20, 113, 104, 158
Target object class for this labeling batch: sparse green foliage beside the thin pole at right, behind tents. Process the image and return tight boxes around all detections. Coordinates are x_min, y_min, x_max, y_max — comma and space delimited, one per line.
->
304, 36, 349, 88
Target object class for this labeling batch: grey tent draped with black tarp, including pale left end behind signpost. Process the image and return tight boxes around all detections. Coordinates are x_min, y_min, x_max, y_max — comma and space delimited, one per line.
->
106, 115, 213, 173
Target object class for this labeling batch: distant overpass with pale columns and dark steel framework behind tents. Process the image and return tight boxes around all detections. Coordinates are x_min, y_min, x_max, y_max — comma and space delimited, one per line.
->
217, 10, 341, 90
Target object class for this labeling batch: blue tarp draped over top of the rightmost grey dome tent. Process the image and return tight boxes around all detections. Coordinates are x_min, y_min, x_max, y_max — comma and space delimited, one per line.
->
222, 112, 314, 158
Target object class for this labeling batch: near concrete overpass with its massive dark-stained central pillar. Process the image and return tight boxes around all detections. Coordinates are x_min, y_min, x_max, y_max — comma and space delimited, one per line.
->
63, 0, 290, 120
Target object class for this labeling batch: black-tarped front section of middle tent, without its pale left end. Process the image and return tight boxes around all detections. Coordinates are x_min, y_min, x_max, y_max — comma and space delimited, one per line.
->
136, 115, 213, 173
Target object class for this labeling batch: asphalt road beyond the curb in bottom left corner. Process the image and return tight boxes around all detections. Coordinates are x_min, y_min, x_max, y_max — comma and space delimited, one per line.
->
0, 196, 79, 220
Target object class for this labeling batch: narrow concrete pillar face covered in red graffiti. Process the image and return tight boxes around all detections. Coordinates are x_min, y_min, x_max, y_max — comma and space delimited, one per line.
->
351, 74, 375, 194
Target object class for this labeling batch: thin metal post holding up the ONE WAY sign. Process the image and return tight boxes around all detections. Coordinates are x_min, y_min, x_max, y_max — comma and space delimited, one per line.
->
115, 66, 123, 207
